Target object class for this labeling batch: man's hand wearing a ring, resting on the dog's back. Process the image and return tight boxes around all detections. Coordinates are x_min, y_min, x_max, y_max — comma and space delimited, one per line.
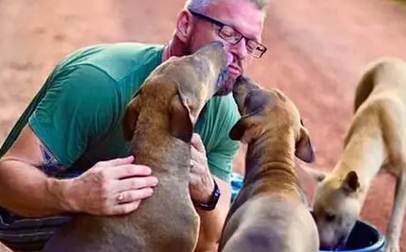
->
64, 156, 158, 215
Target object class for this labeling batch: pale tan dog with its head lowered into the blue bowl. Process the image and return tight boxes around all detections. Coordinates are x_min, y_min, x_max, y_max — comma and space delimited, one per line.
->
310, 58, 406, 252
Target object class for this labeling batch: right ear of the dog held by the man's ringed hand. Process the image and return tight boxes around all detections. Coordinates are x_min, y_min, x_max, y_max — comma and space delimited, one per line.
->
171, 91, 194, 143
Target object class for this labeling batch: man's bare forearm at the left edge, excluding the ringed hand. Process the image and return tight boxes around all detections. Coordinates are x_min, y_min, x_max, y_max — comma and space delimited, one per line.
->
0, 160, 73, 217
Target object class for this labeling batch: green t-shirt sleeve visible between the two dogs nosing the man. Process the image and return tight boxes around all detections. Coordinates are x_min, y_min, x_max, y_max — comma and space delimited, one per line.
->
207, 97, 240, 182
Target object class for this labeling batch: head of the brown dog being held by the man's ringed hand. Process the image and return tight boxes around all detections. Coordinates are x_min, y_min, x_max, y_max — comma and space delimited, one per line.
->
123, 41, 232, 142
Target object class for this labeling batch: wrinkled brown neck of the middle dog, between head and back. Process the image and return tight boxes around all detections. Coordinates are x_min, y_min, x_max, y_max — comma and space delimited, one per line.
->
244, 131, 300, 196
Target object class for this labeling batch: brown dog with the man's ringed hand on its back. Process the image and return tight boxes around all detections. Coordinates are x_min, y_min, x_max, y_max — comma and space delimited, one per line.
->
44, 42, 229, 252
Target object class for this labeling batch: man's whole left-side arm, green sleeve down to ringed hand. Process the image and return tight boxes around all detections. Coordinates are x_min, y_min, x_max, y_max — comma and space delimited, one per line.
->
0, 65, 157, 216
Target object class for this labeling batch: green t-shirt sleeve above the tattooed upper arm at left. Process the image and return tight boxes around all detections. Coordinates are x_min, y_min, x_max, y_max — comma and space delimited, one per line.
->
29, 65, 120, 168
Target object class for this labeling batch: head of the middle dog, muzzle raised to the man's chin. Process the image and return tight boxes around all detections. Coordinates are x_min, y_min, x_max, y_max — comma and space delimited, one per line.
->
230, 76, 314, 163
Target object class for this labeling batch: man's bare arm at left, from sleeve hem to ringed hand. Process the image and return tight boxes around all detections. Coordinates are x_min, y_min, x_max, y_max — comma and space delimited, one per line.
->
0, 126, 157, 217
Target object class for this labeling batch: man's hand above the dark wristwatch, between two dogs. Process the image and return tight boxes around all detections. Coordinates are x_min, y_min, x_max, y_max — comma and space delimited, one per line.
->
189, 133, 214, 203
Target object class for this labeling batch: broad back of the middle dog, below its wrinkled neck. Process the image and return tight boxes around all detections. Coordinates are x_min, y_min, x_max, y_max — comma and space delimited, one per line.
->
222, 195, 318, 252
